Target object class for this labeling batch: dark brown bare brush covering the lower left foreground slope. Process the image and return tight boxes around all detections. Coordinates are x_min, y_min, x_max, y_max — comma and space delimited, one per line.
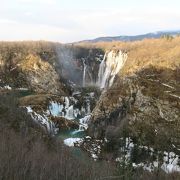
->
0, 94, 113, 180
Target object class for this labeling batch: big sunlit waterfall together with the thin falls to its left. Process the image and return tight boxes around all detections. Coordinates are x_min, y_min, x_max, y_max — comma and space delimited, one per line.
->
82, 50, 127, 89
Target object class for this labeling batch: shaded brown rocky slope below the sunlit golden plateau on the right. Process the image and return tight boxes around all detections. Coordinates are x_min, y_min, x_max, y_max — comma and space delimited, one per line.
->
88, 69, 180, 153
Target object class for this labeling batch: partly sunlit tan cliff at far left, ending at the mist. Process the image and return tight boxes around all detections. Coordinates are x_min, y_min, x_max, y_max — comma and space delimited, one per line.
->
0, 42, 67, 95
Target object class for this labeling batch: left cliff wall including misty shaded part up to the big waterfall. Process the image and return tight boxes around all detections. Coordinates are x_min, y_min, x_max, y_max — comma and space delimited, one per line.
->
0, 42, 104, 95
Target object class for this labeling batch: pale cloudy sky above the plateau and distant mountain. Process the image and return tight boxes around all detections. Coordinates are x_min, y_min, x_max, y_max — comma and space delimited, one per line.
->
0, 0, 180, 43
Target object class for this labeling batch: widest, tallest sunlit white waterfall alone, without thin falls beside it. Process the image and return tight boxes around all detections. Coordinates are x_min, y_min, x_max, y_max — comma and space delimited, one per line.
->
97, 50, 127, 89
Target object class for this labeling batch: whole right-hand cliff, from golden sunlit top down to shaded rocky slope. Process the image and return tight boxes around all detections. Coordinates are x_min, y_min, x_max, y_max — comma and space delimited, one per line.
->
88, 39, 180, 159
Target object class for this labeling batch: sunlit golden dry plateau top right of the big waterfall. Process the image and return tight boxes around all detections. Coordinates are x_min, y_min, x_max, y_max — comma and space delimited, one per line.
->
78, 37, 180, 75
